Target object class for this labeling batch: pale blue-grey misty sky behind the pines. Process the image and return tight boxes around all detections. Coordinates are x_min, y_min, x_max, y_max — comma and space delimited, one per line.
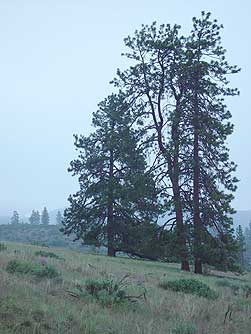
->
0, 0, 251, 215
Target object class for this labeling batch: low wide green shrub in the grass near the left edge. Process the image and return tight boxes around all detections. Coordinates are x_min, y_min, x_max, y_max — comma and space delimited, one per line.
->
6, 260, 59, 278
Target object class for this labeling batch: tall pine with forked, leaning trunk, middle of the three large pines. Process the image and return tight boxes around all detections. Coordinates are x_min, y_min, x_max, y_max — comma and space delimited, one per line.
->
113, 23, 190, 271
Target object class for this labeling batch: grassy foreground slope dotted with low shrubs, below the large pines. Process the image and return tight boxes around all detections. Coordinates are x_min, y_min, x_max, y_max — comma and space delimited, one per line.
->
0, 243, 251, 334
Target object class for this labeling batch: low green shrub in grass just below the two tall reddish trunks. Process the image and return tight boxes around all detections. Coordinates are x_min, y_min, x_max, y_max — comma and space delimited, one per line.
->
160, 278, 218, 300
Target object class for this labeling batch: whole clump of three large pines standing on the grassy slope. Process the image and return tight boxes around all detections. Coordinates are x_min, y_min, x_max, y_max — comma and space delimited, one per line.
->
62, 12, 242, 273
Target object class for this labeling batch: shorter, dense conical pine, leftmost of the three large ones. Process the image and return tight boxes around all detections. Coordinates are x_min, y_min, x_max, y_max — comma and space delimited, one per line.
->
63, 93, 162, 256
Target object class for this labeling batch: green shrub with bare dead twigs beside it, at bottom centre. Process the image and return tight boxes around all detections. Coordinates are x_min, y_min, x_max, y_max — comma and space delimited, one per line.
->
85, 279, 127, 305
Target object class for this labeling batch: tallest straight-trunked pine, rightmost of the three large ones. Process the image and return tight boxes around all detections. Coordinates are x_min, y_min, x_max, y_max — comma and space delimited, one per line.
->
178, 12, 239, 273
